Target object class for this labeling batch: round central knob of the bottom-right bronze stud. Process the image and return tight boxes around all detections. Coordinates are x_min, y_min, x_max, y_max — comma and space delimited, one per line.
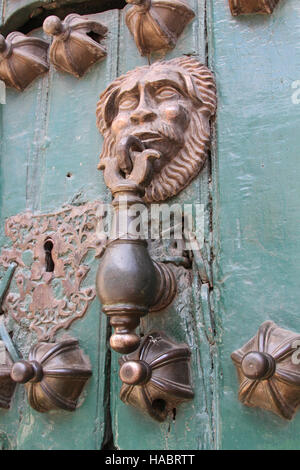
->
241, 351, 275, 380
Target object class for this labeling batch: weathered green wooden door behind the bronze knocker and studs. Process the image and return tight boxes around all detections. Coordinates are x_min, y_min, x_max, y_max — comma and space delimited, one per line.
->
0, 0, 300, 450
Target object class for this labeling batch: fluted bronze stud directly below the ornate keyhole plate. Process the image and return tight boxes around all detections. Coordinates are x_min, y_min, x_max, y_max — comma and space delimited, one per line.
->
11, 339, 92, 413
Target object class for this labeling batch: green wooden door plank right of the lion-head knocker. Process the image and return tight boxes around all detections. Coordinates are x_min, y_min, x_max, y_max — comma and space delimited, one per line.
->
208, 0, 300, 449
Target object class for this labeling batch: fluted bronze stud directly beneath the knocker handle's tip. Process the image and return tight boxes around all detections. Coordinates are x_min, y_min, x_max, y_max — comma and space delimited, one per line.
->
119, 332, 194, 421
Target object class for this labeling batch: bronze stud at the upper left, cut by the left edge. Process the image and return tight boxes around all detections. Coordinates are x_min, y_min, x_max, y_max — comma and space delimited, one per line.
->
0, 31, 49, 91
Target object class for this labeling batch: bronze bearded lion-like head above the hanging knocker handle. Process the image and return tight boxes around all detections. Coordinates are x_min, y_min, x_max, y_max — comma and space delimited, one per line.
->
97, 57, 216, 202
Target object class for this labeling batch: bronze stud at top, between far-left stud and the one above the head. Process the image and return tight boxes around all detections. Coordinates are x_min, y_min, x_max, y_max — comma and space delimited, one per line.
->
43, 13, 107, 78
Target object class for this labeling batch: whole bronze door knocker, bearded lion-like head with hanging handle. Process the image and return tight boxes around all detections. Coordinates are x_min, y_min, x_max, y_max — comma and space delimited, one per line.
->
96, 57, 216, 353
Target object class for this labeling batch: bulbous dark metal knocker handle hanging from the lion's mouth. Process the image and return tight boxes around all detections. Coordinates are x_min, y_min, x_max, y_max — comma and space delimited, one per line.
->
96, 136, 176, 354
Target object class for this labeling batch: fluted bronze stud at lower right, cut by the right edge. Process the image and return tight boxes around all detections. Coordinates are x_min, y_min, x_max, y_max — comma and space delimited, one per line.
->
231, 321, 300, 419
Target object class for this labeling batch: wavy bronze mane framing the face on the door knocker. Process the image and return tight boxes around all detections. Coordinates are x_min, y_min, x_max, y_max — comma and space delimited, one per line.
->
96, 56, 216, 203
